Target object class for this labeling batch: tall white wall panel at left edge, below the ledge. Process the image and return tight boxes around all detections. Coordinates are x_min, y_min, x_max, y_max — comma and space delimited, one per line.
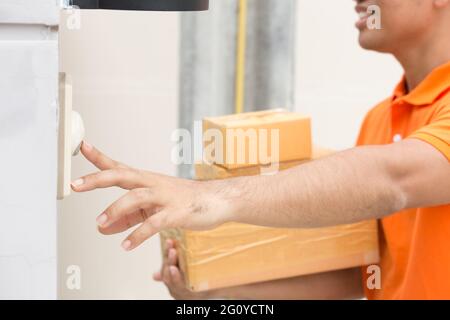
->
0, 39, 58, 299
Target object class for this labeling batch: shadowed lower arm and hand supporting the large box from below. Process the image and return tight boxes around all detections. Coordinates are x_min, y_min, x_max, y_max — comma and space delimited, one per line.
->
153, 239, 363, 300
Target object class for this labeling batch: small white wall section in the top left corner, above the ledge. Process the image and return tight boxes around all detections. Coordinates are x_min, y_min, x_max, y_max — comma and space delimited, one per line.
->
0, 0, 60, 26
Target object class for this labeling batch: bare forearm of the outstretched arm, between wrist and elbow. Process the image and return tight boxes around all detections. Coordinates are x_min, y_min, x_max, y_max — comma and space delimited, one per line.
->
222, 147, 405, 228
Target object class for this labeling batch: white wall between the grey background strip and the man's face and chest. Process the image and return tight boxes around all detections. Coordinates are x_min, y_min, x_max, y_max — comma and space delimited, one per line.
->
296, 0, 402, 149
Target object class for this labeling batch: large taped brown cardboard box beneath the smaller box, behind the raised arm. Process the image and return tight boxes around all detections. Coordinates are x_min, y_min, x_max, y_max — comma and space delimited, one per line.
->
161, 149, 379, 291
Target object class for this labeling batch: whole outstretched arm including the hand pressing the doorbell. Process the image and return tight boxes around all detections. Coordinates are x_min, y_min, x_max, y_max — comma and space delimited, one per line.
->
72, 139, 450, 250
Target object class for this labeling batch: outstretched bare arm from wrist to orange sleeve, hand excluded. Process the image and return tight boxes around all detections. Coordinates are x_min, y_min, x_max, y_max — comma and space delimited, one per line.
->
227, 139, 450, 228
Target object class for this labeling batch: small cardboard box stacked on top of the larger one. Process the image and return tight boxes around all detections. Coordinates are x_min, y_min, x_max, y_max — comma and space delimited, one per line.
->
203, 109, 312, 169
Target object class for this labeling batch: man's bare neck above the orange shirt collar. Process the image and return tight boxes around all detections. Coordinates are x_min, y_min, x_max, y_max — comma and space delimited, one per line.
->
394, 25, 450, 91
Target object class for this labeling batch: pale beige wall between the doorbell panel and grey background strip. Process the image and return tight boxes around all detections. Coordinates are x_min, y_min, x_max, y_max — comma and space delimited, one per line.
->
58, 11, 178, 299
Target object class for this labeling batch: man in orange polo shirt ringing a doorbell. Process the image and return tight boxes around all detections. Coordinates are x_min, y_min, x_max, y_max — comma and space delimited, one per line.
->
73, 0, 450, 299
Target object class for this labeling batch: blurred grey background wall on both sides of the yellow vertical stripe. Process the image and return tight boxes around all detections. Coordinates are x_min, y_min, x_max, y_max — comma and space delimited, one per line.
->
178, 0, 297, 177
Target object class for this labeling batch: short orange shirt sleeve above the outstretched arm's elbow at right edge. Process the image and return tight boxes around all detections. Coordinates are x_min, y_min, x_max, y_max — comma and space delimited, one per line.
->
409, 104, 450, 161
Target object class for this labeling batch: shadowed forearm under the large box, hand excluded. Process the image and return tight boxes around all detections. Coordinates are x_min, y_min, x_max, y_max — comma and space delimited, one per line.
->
209, 268, 363, 300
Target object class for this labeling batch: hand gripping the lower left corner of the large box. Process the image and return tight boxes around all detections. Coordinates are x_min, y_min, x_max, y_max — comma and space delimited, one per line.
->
153, 239, 212, 300
